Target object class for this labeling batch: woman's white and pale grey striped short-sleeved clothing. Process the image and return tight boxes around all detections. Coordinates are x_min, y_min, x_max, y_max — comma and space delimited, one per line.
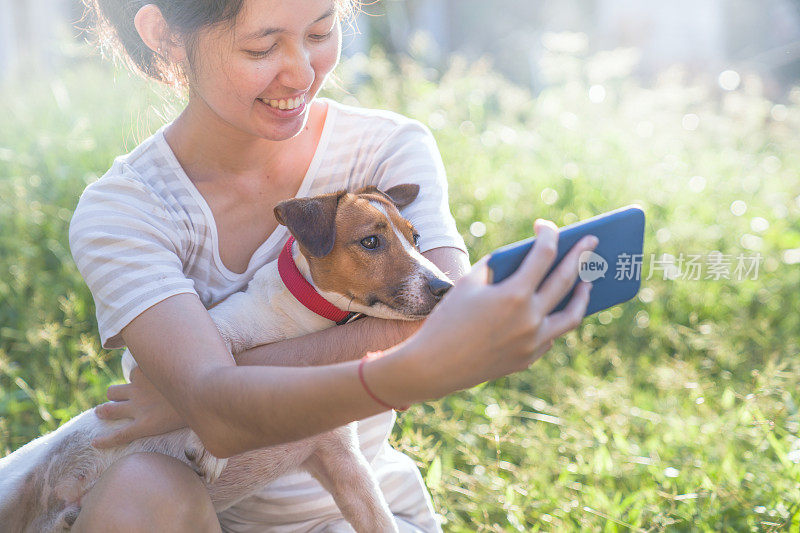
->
69, 99, 466, 532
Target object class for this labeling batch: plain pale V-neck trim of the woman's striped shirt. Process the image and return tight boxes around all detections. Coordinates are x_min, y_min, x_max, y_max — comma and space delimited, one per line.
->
156, 98, 337, 281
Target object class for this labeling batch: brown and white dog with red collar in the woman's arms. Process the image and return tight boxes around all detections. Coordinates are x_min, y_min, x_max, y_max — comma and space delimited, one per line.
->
0, 185, 452, 533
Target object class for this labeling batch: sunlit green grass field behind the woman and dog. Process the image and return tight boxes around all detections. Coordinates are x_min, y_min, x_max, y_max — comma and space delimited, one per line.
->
0, 46, 800, 532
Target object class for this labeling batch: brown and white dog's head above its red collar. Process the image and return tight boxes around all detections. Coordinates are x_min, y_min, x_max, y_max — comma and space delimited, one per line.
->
275, 184, 452, 320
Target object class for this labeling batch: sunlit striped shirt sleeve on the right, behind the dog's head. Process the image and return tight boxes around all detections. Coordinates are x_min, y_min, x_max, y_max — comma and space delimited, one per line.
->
372, 120, 467, 252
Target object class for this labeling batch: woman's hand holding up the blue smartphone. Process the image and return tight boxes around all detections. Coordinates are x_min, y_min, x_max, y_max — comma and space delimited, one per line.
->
365, 220, 597, 405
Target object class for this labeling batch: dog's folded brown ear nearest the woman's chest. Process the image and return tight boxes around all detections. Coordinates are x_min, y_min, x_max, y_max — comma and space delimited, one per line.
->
274, 193, 342, 257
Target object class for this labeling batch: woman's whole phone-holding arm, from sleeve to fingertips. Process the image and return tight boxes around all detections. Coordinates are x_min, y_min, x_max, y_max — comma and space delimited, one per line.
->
122, 224, 596, 457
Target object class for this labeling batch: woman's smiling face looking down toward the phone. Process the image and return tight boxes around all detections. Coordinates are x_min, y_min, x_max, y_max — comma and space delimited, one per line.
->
189, 0, 342, 141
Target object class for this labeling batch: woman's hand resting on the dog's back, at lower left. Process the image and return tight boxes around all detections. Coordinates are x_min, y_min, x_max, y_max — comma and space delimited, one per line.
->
92, 366, 186, 448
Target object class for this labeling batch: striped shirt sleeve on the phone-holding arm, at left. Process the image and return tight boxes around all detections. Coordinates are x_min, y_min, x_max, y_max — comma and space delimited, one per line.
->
69, 165, 197, 348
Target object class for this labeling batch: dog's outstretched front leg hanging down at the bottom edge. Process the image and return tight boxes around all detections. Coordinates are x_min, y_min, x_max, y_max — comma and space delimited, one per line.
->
303, 423, 397, 533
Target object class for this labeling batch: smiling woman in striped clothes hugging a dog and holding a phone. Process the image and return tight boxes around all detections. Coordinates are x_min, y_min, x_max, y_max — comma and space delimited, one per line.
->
70, 0, 592, 531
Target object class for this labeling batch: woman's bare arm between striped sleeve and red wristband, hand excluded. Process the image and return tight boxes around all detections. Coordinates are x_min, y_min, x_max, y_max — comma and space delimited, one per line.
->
122, 294, 390, 457
